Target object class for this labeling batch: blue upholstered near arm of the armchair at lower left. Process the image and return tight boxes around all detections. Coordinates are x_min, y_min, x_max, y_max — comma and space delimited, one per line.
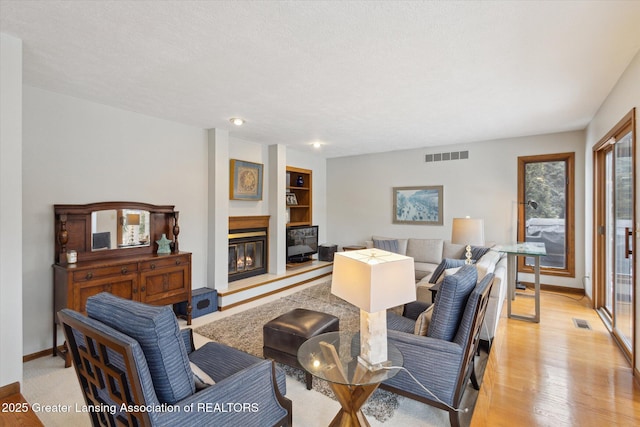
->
156, 360, 288, 426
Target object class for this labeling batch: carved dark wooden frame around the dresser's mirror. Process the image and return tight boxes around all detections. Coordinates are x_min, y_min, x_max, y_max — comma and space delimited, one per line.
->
53, 202, 180, 264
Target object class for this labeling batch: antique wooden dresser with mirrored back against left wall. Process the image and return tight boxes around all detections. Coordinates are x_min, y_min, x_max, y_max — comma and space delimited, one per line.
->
53, 202, 191, 367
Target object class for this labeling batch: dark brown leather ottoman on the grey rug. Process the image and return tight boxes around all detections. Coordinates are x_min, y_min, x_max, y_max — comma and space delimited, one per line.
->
262, 308, 340, 390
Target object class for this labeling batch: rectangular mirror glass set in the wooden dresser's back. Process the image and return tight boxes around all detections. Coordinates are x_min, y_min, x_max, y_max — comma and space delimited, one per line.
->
91, 209, 151, 251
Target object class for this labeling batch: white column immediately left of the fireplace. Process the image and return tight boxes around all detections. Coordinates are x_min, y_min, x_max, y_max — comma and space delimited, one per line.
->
207, 129, 229, 290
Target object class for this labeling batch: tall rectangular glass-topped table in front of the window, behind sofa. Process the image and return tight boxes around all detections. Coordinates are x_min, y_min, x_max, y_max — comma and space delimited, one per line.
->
494, 242, 547, 323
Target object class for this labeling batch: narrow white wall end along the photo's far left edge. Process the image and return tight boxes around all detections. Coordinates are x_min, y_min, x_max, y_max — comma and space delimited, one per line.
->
0, 34, 23, 387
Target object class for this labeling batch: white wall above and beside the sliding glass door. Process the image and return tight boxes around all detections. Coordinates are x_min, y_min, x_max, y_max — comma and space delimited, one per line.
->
584, 52, 640, 374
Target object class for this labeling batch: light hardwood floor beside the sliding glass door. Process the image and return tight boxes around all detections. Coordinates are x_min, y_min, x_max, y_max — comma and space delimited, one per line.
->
471, 290, 640, 427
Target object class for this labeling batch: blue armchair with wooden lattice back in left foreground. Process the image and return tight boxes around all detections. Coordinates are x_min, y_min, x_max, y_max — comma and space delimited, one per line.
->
58, 293, 292, 426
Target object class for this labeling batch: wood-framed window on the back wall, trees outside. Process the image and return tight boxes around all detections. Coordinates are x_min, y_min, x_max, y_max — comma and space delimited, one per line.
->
517, 153, 575, 277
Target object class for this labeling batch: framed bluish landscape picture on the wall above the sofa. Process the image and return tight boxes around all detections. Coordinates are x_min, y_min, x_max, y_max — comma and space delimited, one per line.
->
393, 185, 443, 225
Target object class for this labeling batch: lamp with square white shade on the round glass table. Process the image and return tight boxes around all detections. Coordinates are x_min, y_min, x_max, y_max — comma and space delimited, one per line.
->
331, 249, 416, 370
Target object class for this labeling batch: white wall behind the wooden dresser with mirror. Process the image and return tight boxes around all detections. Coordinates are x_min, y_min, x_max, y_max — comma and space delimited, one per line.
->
21, 86, 207, 354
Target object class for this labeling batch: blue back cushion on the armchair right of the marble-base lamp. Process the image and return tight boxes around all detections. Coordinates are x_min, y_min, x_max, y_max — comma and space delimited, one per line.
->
427, 265, 478, 341
